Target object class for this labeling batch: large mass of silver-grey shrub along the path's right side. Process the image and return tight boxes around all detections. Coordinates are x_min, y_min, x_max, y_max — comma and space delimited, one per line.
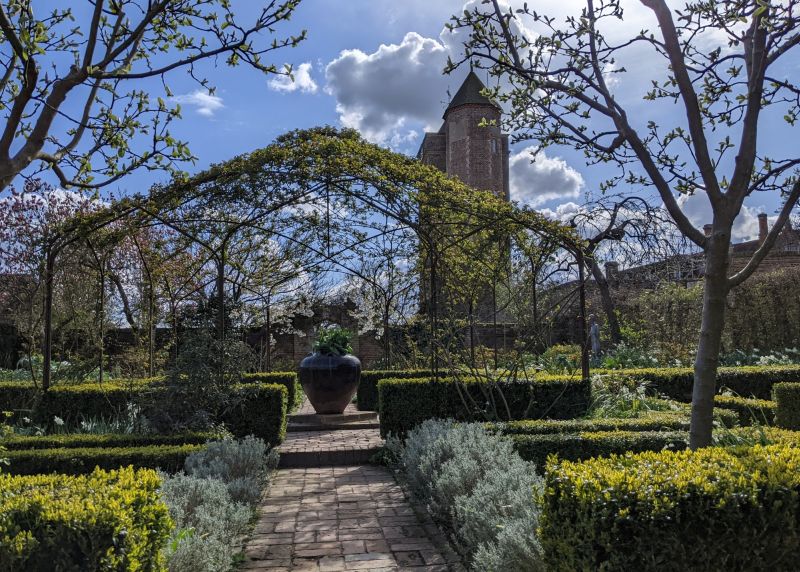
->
398, 420, 542, 571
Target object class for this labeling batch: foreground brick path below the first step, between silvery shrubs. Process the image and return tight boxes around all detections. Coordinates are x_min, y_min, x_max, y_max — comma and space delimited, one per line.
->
242, 465, 461, 572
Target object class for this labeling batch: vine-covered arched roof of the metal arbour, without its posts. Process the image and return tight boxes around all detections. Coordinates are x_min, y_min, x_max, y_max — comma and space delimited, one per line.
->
45, 128, 581, 388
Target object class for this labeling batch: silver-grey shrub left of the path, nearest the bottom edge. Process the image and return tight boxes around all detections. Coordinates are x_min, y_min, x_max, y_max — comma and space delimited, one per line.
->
161, 474, 252, 572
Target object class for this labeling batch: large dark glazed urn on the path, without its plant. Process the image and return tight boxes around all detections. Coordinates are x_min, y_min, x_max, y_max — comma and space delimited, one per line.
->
300, 352, 361, 414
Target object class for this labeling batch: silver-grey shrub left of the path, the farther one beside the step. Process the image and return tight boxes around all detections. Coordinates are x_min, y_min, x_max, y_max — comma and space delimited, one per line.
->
184, 435, 278, 505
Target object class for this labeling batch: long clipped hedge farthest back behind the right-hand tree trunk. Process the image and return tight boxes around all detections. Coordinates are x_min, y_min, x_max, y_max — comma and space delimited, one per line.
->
592, 365, 800, 403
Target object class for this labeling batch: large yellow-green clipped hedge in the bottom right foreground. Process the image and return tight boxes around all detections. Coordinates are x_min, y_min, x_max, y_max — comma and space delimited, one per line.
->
540, 445, 800, 572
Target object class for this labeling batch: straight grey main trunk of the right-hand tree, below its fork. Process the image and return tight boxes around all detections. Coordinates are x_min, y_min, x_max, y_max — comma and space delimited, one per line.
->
689, 224, 731, 449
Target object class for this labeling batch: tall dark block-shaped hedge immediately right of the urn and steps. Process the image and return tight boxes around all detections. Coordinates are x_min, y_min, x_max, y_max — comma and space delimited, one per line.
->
378, 376, 591, 437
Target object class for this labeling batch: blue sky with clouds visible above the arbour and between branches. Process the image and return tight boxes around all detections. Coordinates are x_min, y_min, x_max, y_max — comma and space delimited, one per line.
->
21, 0, 800, 240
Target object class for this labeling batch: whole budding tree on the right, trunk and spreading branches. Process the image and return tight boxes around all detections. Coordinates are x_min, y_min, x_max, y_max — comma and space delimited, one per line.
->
452, 0, 800, 448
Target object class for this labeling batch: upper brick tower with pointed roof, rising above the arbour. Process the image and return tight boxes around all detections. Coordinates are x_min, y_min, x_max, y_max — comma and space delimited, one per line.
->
417, 70, 509, 200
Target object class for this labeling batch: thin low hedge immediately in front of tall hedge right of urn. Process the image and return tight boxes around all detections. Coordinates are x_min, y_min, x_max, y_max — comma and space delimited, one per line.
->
486, 410, 738, 435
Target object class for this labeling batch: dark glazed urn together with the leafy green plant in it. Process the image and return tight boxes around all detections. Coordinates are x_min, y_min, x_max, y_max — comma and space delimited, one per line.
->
300, 327, 361, 414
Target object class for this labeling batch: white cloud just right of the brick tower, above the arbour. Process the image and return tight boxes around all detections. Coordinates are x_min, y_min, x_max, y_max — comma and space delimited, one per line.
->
508, 148, 584, 207
